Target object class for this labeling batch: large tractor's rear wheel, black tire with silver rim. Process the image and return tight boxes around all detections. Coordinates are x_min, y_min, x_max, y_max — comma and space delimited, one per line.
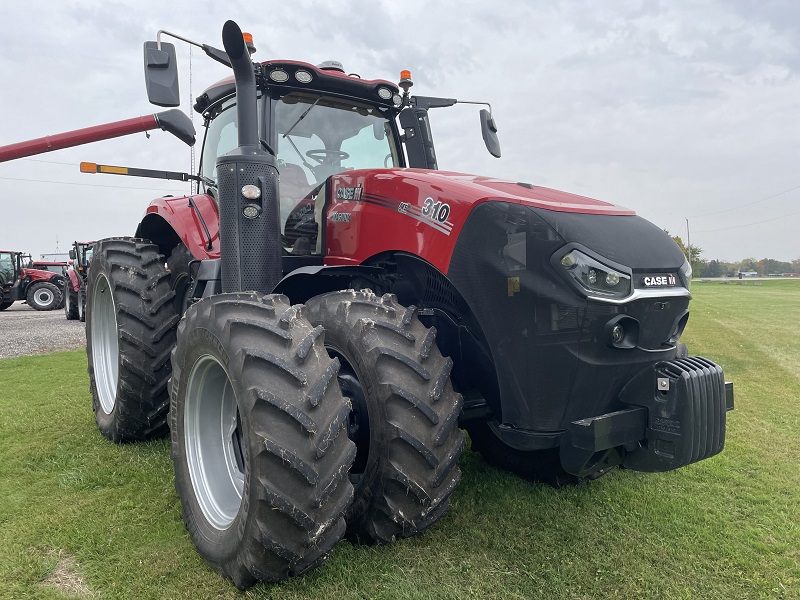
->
86, 238, 179, 443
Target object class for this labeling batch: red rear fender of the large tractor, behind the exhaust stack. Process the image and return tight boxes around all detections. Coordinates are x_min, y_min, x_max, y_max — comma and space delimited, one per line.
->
135, 194, 219, 260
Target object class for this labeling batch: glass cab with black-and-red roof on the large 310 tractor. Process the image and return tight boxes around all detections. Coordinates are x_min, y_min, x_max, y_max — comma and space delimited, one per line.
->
194, 61, 406, 254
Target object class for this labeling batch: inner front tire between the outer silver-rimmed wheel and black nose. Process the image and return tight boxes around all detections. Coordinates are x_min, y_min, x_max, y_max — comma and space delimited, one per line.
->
306, 290, 464, 543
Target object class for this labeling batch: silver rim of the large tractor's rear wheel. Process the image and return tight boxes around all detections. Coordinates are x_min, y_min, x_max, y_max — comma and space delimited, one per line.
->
91, 275, 119, 414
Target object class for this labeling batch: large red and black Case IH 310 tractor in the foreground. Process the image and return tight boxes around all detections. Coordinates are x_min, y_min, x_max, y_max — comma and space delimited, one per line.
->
0, 21, 733, 588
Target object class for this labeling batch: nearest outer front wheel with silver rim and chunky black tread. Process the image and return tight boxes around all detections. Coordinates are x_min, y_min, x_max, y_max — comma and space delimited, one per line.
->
170, 292, 356, 589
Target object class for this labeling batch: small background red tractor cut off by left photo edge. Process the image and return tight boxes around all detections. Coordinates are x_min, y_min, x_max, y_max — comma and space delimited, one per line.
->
0, 250, 64, 310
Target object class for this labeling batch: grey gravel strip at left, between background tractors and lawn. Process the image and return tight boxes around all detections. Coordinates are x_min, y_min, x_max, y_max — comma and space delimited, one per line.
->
0, 302, 86, 358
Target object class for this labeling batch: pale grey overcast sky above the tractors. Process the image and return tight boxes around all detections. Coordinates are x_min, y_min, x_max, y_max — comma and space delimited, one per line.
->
0, 0, 800, 261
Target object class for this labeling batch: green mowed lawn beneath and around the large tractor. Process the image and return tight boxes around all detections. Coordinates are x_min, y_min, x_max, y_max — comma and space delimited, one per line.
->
0, 281, 800, 600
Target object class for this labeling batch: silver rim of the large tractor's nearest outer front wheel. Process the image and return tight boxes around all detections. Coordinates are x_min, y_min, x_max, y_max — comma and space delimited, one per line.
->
183, 355, 244, 530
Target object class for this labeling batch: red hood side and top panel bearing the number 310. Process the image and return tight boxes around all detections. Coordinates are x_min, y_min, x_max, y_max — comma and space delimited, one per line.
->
325, 169, 635, 272
